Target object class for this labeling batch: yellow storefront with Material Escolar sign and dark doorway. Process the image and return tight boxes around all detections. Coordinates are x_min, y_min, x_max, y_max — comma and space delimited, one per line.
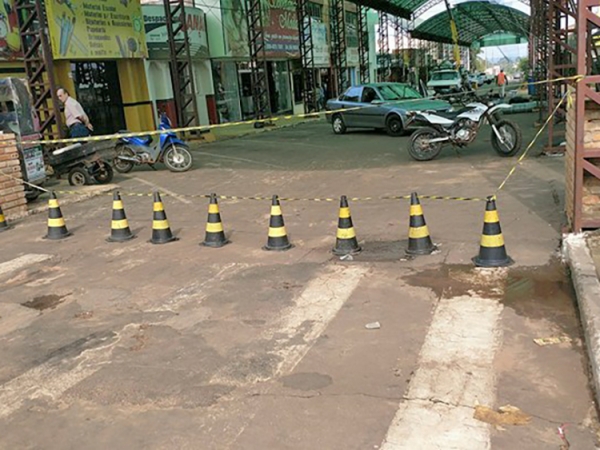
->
46, 0, 154, 134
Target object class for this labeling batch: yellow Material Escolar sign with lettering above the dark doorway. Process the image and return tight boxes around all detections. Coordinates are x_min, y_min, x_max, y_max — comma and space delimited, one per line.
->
45, 0, 148, 59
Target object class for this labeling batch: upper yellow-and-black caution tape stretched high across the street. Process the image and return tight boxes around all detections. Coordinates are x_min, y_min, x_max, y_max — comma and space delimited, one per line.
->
27, 75, 585, 145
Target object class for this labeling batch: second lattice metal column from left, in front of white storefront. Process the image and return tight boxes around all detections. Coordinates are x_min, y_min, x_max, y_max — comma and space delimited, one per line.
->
164, 0, 200, 131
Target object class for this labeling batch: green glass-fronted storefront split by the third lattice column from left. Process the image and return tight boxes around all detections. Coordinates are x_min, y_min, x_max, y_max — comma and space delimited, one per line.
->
207, 0, 302, 123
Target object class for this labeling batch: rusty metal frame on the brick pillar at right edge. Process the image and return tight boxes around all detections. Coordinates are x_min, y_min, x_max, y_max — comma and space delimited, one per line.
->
571, 0, 600, 232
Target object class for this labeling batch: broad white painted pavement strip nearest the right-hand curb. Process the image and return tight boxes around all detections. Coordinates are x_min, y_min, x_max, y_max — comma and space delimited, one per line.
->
381, 296, 502, 450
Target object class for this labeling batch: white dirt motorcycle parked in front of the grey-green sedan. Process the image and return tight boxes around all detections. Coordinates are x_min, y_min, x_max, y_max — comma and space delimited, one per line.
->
408, 98, 522, 161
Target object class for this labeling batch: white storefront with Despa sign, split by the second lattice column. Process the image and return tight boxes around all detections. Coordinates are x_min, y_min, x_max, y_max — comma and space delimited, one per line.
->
142, 3, 217, 126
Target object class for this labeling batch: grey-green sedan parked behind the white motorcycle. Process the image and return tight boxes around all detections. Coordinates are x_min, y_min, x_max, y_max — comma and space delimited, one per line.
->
325, 83, 452, 136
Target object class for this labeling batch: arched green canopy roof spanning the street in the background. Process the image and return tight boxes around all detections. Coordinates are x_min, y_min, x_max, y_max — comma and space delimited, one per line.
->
412, 1, 529, 46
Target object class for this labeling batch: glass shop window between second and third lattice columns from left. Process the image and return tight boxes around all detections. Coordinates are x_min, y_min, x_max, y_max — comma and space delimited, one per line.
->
212, 61, 242, 123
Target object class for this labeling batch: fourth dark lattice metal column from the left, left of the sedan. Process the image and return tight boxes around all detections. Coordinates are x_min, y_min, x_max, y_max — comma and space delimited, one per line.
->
296, 0, 319, 113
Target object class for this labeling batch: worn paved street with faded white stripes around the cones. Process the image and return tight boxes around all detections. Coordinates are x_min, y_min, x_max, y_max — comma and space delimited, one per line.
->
0, 114, 599, 450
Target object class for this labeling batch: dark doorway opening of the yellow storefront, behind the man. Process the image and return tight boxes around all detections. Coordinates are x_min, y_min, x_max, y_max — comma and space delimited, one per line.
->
71, 61, 126, 134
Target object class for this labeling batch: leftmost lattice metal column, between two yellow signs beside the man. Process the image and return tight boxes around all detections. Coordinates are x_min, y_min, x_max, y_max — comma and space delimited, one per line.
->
16, 0, 64, 139
